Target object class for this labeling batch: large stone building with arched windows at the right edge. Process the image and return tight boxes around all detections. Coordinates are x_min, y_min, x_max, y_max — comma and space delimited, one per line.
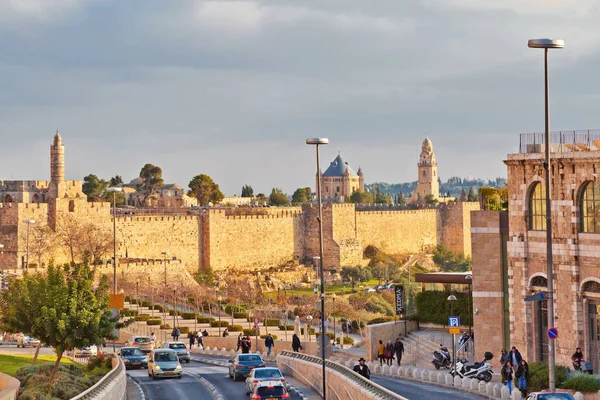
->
472, 131, 600, 372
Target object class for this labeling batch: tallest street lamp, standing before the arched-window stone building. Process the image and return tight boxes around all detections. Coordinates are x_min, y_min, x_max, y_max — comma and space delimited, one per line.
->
527, 39, 565, 392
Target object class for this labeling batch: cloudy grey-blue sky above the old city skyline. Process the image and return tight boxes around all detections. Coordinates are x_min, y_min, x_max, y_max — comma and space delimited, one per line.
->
0, 0, 600, 196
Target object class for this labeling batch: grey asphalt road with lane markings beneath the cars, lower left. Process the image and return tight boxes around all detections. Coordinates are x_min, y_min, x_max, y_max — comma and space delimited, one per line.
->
127, 362, 300, 400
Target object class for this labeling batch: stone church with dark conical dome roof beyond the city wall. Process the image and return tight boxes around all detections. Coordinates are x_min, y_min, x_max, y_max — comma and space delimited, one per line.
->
321, 153, 365, 199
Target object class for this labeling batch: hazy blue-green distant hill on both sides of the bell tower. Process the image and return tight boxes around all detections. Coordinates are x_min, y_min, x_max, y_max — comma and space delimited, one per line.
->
365, 176, 506, 197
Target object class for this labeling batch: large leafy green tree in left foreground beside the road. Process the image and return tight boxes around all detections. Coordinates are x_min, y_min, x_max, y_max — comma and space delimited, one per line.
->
0, 264, 116, 380
